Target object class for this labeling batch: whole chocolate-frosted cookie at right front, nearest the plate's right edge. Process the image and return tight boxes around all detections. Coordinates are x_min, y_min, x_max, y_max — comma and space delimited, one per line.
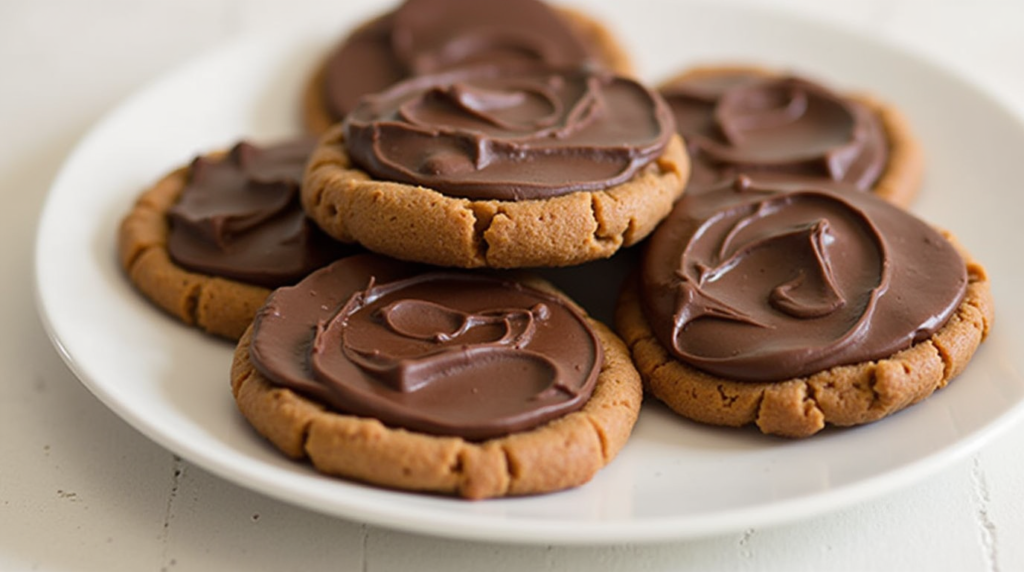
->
616, 175, 993, 437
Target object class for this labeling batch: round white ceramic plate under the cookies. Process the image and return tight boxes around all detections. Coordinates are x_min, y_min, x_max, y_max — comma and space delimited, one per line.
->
37, 0, 1024, 543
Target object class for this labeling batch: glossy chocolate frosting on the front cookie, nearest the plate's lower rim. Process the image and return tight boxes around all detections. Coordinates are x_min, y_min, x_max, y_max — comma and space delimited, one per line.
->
250, 255, 602, 440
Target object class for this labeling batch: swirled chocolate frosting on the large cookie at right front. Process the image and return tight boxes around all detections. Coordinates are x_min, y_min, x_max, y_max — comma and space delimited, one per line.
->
642, 175, 967, 382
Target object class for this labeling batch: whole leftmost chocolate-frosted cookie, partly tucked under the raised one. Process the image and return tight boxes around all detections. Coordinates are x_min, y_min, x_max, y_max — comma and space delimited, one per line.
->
118, 139, 355, 340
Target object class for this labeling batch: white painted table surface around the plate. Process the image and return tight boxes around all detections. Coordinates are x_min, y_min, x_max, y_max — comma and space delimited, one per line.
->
0, 0, 1024, 572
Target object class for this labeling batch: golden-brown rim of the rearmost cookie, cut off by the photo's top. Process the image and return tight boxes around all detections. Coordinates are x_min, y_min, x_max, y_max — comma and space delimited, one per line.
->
302, 8, 633, 135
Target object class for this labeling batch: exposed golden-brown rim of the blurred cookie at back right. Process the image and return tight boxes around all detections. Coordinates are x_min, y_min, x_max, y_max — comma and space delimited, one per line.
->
659, 65, 925, 208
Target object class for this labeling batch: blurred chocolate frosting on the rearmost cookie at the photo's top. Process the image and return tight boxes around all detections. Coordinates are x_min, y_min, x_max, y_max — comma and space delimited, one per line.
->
324, 0, 594, 120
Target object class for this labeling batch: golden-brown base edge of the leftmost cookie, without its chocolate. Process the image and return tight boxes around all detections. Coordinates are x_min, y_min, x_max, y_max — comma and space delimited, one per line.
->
118, 159, 270, 340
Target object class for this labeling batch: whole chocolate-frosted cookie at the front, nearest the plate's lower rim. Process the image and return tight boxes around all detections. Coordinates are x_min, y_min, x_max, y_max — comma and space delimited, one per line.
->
231, 254, 641, 498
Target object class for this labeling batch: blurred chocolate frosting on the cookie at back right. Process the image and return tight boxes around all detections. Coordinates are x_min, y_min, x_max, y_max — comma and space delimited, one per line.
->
660, 72, 889, 192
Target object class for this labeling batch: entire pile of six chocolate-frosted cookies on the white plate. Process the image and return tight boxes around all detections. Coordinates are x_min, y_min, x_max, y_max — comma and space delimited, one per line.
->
119, 0, 992, 498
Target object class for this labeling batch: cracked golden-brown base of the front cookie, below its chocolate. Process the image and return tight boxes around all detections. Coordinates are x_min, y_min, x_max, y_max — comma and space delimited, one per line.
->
231, 284, 643, 498
